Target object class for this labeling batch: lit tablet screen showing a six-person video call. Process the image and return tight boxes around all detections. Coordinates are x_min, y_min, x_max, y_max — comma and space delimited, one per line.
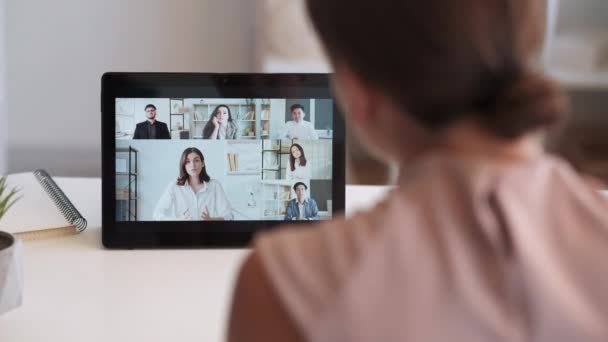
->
115, 97, 334, 222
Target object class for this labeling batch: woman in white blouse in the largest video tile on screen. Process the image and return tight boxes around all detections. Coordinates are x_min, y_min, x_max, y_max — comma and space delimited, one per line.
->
154, 147, 233, 221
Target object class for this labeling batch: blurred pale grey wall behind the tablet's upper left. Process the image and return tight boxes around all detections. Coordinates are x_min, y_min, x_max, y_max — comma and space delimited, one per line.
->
5, 0, 255, 176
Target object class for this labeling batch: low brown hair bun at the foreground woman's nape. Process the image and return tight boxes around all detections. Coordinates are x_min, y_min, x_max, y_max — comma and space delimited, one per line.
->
482, 72, 568, 138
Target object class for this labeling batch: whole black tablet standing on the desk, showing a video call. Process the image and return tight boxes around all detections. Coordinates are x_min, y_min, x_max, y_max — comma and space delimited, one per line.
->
101, 73, 345, 248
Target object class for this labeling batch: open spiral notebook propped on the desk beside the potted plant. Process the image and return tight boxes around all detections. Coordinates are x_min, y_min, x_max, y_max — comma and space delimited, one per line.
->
0, 170, 87, 240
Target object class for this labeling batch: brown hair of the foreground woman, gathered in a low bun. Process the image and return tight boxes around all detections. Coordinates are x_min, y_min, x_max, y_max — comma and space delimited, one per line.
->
307, 0, 566, 138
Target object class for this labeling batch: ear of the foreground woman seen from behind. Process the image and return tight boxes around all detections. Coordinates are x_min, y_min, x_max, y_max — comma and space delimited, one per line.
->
332, 65, 378, 123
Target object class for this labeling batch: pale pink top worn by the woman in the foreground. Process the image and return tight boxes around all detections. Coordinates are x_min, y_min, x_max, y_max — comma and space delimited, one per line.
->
256, 156, 608, 342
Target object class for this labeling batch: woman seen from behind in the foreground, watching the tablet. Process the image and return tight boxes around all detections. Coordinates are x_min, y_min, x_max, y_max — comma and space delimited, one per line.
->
228, 0, 608, 342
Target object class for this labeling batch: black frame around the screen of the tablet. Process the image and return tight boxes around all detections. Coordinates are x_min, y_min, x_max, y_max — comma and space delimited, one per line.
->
101, 72, 345, 248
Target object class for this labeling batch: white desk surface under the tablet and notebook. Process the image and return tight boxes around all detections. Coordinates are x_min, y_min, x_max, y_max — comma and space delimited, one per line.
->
0, 178, 386, 342
